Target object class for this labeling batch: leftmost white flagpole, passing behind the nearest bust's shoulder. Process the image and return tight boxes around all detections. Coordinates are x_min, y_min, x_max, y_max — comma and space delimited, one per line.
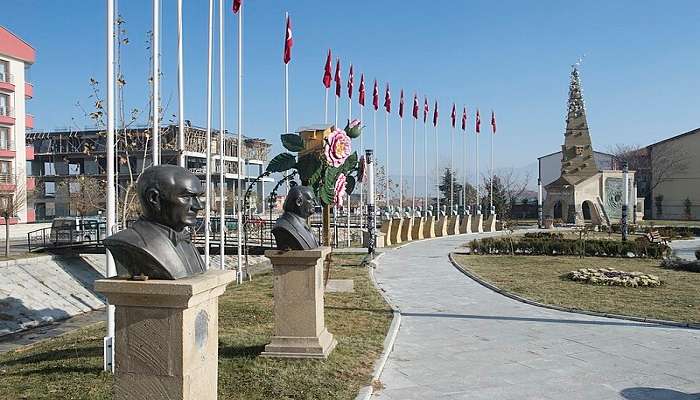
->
103, 0, 117, 373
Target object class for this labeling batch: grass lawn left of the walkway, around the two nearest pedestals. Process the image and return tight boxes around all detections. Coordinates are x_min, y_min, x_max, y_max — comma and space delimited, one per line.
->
0, 255, 392, 400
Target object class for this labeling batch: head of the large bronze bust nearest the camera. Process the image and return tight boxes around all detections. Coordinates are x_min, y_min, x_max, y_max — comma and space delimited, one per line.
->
137, 165, 204, 232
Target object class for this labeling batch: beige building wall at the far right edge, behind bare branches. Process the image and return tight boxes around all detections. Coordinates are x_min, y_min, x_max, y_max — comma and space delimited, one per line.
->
650, 131, 700, 220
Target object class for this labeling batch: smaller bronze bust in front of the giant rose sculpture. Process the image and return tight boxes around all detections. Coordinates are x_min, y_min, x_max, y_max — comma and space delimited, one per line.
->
272, 186, 319, 250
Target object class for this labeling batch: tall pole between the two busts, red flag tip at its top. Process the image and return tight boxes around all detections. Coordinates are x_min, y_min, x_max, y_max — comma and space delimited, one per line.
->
236, 3, 245, 284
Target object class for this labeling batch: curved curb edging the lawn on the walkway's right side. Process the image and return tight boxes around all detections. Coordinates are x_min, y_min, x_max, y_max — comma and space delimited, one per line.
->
448, 253, 700, 329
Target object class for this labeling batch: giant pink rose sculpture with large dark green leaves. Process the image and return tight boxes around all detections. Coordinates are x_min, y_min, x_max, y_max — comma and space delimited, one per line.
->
267, 120, 363, 205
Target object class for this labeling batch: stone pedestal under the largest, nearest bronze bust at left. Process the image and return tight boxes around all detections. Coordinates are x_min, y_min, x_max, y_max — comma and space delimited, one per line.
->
95, 270, 236, 400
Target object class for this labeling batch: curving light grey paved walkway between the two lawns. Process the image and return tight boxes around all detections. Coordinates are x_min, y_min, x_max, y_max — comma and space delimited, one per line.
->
375, 235, 700, 400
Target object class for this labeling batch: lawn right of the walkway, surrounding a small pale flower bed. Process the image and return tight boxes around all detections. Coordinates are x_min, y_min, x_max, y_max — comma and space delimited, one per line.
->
455, 255, 700, 322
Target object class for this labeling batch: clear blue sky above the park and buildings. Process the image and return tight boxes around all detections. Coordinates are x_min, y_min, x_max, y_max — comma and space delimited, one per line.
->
0, 0, 700, 188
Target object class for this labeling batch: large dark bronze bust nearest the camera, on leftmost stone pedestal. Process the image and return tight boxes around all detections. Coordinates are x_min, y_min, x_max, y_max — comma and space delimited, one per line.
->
104, 165, 206, 279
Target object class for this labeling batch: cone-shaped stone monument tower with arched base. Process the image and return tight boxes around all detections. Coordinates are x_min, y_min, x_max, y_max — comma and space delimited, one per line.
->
543, 63, 636, 225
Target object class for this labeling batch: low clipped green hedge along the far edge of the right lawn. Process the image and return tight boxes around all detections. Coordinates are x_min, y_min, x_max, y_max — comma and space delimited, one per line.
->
469, 235, 671, 258
